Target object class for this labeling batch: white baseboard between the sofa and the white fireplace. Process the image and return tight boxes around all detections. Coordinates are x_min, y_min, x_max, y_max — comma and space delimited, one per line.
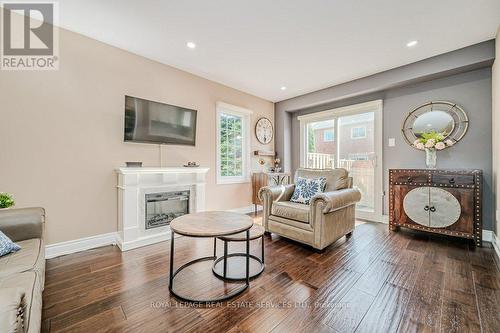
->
45, 232, 117, 259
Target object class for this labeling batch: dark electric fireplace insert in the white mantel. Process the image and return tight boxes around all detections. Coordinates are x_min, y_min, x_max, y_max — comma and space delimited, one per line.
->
146, 191, 189, 229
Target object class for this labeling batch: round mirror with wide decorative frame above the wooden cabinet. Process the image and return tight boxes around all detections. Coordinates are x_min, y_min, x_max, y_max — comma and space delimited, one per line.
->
402, 101, 469, 145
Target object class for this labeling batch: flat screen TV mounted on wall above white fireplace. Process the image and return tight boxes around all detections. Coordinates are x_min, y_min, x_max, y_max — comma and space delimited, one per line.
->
124, 96, 196, 146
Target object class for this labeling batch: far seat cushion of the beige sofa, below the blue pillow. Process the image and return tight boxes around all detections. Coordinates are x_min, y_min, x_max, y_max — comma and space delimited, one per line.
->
0, 239, 45, 278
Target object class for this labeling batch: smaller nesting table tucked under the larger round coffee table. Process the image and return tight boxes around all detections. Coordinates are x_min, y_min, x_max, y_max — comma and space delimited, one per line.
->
212, 224, 265, 281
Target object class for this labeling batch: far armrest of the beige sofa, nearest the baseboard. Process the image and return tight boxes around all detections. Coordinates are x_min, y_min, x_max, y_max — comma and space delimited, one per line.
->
0, 207, 45, 242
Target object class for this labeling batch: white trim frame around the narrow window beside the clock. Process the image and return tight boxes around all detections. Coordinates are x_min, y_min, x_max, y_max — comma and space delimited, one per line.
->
215, 102, 253, 184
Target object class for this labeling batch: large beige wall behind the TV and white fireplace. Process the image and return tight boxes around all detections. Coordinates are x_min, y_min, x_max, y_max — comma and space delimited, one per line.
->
0, 26, 274, 244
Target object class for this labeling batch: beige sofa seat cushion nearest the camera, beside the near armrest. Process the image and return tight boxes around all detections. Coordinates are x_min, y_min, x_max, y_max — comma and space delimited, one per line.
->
0, 271, 42, 333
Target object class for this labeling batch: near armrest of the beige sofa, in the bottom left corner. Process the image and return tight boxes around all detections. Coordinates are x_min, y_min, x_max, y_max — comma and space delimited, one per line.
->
0, 288, 25, 332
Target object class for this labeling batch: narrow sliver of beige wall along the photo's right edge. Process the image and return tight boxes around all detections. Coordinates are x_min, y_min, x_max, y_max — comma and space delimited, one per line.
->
491, 26, 500, 236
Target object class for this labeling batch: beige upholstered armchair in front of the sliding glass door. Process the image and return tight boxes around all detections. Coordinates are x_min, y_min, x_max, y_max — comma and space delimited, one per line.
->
259, 168, 361, 250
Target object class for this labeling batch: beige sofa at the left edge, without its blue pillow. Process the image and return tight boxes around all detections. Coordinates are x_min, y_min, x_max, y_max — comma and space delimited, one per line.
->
0, 208, 45, 333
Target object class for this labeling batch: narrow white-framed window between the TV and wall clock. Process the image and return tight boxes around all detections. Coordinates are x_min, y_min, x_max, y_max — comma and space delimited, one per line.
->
216, 102, 252, 184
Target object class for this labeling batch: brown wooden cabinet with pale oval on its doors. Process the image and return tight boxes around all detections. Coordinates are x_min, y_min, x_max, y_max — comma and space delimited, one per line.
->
389, 169, 482, 246
